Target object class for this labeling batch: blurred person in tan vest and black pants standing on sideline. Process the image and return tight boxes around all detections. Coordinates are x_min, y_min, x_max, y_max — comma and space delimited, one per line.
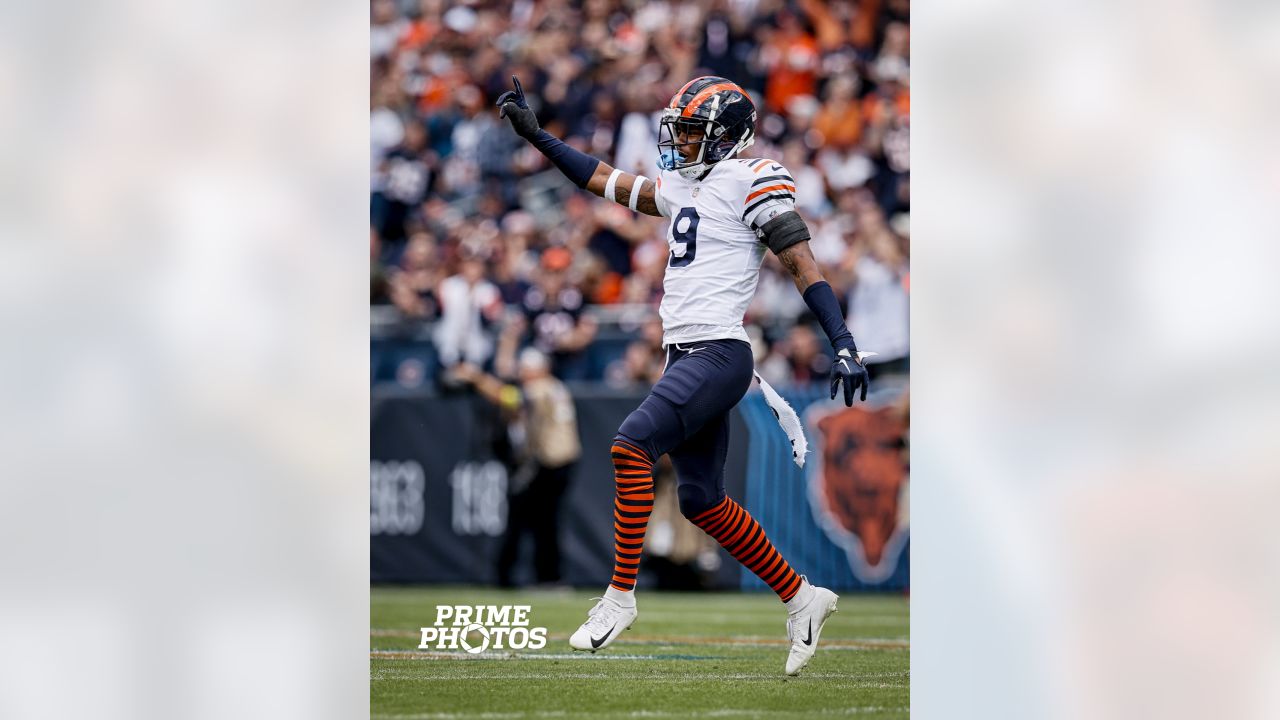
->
453, 348, 582, 587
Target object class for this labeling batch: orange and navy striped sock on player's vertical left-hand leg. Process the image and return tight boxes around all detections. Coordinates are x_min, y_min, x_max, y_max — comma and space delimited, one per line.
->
609, 438, 653, 592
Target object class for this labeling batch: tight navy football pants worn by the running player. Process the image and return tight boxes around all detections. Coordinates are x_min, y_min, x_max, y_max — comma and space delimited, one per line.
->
618, 340, 754, 518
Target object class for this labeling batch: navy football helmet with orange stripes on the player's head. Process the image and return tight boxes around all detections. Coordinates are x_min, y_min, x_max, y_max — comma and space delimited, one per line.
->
658, 76, 755, 179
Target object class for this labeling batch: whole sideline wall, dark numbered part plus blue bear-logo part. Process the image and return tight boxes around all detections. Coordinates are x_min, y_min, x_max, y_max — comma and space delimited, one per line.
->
369, 382, 910, 592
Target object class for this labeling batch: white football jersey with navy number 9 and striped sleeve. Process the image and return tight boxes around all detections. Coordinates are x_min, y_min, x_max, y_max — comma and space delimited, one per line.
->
655, 159, 796, 345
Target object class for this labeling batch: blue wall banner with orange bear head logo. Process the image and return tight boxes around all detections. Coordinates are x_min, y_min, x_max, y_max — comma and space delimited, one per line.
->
739, 379, 910, 591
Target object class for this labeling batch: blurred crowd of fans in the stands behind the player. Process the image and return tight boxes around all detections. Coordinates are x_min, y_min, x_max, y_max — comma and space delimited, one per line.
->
370, 0, 910, 387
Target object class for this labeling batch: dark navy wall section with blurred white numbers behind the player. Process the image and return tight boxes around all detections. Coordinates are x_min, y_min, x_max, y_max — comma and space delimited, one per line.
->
369, 388, 748, 588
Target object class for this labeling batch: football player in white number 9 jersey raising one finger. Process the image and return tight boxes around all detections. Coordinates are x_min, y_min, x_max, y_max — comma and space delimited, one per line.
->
498, 77, 867, 675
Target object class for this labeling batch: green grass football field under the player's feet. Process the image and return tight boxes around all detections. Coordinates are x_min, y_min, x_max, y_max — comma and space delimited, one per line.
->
369, 587, 910, 720
